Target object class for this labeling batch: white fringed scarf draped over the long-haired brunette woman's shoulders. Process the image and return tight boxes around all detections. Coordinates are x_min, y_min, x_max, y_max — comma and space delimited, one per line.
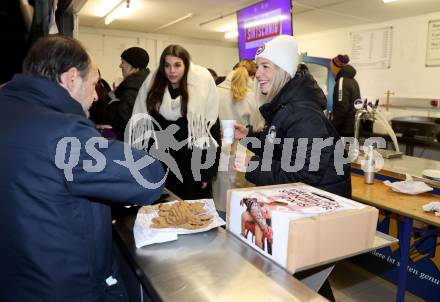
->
128, 63, 219, 149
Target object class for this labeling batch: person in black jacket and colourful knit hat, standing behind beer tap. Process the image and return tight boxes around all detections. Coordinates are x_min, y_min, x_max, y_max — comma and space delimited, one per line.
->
330, 55, 361, 137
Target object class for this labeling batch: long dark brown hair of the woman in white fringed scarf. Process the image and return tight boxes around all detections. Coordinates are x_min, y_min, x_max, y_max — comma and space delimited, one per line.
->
146, 45, 191, 116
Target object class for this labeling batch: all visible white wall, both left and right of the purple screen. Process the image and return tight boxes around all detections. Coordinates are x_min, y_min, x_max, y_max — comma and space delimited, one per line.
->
79, 12, 440, 109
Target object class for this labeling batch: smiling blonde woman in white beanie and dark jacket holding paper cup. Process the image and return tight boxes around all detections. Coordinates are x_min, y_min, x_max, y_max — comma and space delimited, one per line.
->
234, 35, 351, 197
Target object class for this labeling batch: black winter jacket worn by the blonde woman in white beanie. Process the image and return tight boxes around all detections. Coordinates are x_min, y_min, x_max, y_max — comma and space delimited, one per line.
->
246, 65, 351, 198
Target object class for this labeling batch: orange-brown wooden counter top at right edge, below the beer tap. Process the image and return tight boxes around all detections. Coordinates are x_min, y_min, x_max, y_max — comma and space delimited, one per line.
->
351, 174, 440, 227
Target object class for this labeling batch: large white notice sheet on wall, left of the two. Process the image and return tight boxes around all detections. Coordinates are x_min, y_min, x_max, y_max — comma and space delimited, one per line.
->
350, 26, 393, 69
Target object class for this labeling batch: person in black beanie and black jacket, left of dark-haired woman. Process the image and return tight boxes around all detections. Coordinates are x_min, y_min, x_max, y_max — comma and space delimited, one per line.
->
90, 47, 150, 140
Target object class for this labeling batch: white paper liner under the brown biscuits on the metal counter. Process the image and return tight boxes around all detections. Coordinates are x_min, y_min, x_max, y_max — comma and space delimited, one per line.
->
133, 199, 225, 248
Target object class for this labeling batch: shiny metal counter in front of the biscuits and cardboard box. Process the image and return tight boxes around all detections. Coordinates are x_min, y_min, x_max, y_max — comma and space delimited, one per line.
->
114, 202, 326, 302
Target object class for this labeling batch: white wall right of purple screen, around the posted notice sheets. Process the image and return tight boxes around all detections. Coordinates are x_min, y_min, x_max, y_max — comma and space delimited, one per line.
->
294, 12, 440, 100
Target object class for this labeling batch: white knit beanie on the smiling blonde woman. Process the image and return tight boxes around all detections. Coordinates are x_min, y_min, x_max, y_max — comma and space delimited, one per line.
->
255, 35, 298, 78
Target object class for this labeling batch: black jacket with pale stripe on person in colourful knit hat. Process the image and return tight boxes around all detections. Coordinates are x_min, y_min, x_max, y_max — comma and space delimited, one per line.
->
332, 65, 361, 136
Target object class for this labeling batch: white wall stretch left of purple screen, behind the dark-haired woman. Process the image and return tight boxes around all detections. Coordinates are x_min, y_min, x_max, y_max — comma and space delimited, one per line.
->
78, 26, 238, 84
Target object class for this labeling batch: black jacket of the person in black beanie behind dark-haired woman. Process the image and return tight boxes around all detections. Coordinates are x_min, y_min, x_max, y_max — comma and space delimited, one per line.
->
104, 68, 150, 140
